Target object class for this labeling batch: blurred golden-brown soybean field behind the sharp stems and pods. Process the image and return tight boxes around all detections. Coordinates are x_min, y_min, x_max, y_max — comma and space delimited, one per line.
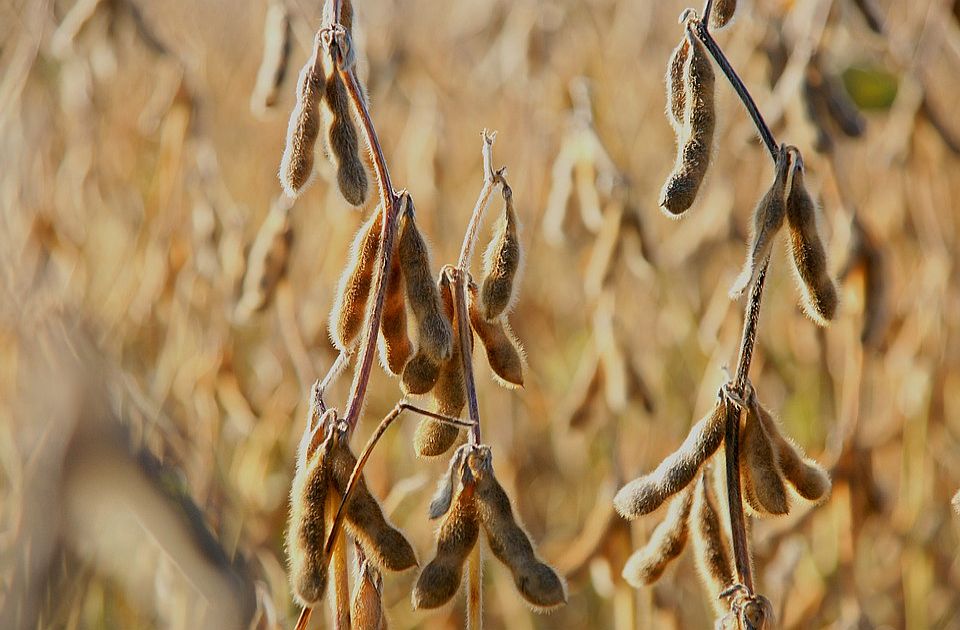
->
0, 0, 960, 630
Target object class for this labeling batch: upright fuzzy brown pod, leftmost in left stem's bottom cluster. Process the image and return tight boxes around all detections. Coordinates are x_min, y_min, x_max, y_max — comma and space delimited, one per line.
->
287, 431, 330, 606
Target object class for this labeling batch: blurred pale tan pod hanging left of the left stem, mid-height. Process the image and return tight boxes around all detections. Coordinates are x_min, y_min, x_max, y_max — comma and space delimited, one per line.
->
236, 196, 293, 320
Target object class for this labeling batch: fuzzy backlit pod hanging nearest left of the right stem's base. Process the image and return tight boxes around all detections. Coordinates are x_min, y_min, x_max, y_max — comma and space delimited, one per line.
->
690, 469, 734, 612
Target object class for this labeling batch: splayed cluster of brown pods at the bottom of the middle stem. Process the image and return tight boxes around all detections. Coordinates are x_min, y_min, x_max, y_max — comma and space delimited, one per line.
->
412, 445, 567, 611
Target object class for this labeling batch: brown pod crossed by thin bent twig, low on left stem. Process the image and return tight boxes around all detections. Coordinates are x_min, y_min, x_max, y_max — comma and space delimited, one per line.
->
330, 430, 417, 571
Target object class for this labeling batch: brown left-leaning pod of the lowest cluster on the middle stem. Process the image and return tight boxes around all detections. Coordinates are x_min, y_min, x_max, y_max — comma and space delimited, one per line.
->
412, 480, 480, 609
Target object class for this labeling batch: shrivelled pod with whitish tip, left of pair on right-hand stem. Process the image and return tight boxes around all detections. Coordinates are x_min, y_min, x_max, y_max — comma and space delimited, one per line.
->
730, 145, 790, 299
